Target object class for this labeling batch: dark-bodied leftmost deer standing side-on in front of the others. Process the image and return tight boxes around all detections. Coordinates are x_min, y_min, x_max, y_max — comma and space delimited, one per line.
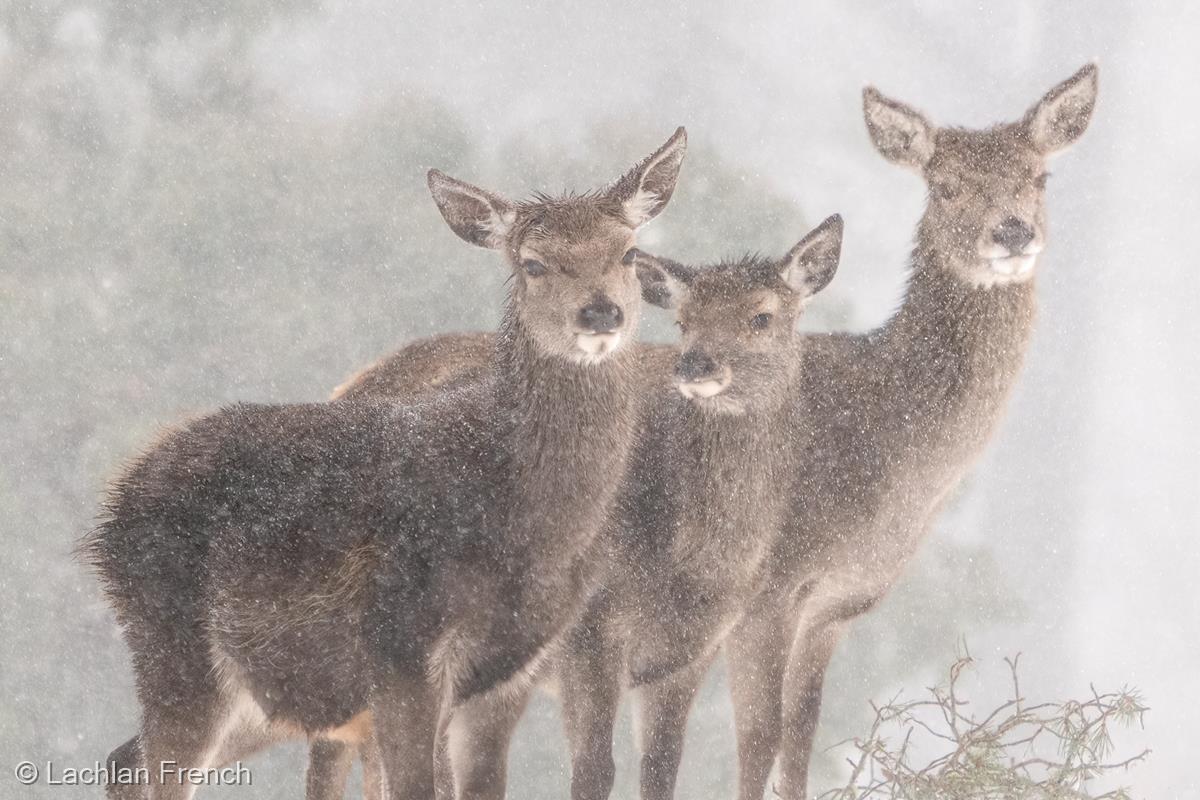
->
82, 128, 685, 800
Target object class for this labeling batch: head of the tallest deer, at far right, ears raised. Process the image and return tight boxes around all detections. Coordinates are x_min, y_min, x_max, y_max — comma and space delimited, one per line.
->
863, 64, 1098, 287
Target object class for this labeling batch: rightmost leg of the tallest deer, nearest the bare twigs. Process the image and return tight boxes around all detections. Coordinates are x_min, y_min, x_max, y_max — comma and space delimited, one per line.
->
779, 620, 846, 800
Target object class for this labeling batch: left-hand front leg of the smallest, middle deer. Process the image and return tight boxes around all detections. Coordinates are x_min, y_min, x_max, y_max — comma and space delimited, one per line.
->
558, 627, 622, 800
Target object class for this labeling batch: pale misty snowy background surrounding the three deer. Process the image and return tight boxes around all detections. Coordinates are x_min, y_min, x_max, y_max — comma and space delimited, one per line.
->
0, 0, 1200, 799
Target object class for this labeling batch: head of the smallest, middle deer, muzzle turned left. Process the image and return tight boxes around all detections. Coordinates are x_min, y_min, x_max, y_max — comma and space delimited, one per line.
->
634, 215, 842, 414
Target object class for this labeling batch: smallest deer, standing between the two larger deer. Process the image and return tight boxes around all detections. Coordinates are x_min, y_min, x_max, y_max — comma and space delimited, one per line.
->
331, 217, 841, 799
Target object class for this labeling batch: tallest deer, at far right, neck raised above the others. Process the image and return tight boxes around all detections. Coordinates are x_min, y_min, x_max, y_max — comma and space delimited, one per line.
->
727, 65, 1097, 800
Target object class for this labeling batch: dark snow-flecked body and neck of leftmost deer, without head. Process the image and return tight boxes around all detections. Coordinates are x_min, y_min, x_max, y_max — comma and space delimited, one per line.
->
85, 307, 632, 758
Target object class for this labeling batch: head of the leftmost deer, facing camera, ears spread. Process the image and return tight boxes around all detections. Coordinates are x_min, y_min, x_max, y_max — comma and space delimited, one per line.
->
428, 128, 688, 363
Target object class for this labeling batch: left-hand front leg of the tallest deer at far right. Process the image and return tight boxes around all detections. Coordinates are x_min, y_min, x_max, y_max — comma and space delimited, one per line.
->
725, 607, 788, 800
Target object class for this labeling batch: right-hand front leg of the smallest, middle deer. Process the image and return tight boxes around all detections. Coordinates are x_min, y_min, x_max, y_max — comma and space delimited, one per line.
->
637, 656, 713, 800
